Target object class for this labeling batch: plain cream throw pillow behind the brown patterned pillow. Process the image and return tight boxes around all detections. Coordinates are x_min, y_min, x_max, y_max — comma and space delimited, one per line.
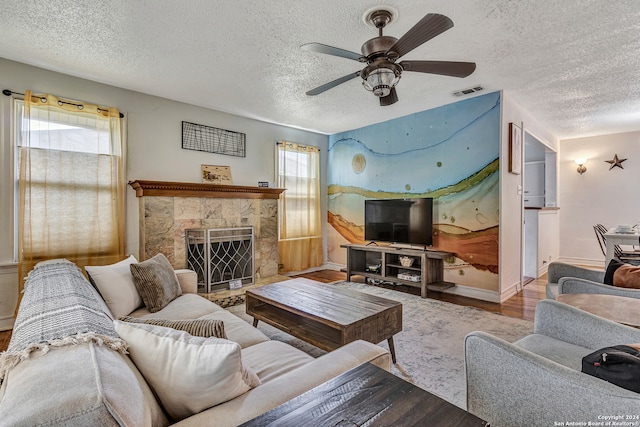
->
84, 255, 142, 319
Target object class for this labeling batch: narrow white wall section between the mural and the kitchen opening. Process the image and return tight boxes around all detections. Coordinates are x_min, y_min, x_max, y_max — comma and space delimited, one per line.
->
500, 91, 558, 301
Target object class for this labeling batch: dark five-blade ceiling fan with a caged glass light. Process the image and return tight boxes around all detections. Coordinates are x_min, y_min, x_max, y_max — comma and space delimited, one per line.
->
302, 8, 476, 106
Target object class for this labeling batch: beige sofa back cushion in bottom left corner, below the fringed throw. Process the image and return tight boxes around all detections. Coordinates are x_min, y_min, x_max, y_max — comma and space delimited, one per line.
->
0, 343, 169, 426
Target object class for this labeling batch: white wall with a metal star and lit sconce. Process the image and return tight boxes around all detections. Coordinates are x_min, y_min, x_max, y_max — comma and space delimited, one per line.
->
558, 132, 640, 266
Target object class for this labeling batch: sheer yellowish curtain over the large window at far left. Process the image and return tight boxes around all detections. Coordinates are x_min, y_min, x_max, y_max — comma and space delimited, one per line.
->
16, 91, 125, 310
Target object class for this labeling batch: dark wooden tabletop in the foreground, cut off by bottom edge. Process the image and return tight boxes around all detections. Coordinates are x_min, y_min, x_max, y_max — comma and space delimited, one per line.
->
242, 363, 489, 427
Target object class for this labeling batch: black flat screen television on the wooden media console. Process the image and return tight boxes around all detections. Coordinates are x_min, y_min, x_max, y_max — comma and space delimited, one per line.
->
364, 197, 433, 246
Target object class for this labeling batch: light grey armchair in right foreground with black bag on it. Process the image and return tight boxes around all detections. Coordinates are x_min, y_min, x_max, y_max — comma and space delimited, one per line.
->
465, 300, 640, 427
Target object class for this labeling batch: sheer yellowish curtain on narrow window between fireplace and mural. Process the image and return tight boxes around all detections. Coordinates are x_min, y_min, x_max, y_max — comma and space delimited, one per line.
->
276, 141, 323, 273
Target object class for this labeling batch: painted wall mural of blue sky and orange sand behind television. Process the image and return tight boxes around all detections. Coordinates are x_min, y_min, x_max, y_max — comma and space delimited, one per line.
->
327, 92, 500, 291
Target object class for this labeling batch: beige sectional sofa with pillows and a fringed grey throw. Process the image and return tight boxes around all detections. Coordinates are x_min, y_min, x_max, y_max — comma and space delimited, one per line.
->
0, 257, 390, 427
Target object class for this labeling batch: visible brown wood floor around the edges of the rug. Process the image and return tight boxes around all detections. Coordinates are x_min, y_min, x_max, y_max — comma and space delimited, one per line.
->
0, 270, 547, 351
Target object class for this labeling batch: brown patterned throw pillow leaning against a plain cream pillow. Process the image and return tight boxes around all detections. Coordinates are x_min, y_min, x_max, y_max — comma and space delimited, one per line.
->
127, 253, 182, 314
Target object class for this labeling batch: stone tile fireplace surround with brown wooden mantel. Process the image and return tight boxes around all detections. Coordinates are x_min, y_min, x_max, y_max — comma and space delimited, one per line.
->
129, 180, 284, 289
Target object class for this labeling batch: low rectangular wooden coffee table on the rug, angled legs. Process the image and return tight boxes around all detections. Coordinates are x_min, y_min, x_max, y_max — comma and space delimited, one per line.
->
245, 279, 402, 363
